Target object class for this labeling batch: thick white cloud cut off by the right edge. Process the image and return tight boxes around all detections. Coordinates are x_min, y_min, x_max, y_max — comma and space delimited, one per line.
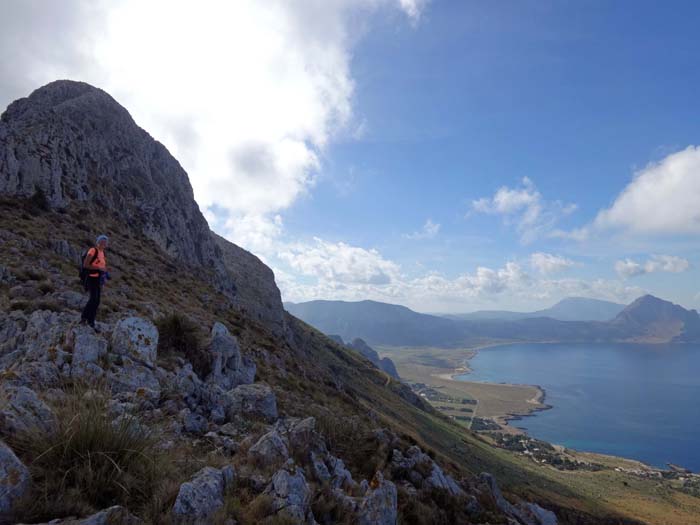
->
593, 146, 700, 235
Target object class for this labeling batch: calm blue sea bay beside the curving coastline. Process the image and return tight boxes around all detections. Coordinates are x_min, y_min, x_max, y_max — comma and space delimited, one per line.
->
460, 344, 700, 472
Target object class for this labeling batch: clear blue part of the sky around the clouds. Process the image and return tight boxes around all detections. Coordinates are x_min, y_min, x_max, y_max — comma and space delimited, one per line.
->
274, 2, 700, 308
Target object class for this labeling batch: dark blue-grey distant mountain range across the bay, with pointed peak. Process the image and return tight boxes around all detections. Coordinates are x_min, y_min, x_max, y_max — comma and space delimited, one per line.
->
285, 295, 700, 347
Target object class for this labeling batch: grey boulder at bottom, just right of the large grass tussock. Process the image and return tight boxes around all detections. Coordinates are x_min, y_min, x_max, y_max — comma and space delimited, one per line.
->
172, 467, 235, 525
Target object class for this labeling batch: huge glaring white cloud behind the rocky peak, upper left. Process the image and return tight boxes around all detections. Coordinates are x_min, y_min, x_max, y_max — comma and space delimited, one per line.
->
0, 0, 426, 252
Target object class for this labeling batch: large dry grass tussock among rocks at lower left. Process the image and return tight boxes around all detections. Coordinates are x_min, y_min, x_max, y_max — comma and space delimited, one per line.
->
10, 389, 161, 521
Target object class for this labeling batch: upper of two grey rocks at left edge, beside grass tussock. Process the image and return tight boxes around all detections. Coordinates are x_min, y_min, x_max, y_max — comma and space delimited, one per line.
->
0, 385, 56, 436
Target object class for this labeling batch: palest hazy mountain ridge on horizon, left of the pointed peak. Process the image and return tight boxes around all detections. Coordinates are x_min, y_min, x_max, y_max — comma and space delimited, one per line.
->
443, 297, 625, 321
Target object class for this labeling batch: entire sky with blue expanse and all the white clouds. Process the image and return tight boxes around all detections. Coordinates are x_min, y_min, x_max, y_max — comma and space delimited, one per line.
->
0, 0, 700, 313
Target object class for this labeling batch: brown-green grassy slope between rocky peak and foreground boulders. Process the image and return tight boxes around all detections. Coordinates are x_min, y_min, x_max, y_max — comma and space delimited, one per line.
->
0, 201, 700, 524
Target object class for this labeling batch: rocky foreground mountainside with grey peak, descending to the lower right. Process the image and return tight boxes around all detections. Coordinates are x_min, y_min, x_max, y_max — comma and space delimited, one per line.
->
0, 81, 700, 525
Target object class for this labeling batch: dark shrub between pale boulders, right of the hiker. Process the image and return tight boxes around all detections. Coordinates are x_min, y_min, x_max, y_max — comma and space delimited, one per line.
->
156, 314, 211, 379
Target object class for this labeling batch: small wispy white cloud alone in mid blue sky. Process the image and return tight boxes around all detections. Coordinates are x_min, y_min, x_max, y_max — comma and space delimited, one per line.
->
472, 177, 576, 244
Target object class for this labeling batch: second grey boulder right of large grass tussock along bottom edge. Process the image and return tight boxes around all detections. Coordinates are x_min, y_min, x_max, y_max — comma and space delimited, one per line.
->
264, 467, 315, 524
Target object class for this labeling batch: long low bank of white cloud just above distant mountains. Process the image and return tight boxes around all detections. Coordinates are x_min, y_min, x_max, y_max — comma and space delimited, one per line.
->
275, 239, 644, 311
